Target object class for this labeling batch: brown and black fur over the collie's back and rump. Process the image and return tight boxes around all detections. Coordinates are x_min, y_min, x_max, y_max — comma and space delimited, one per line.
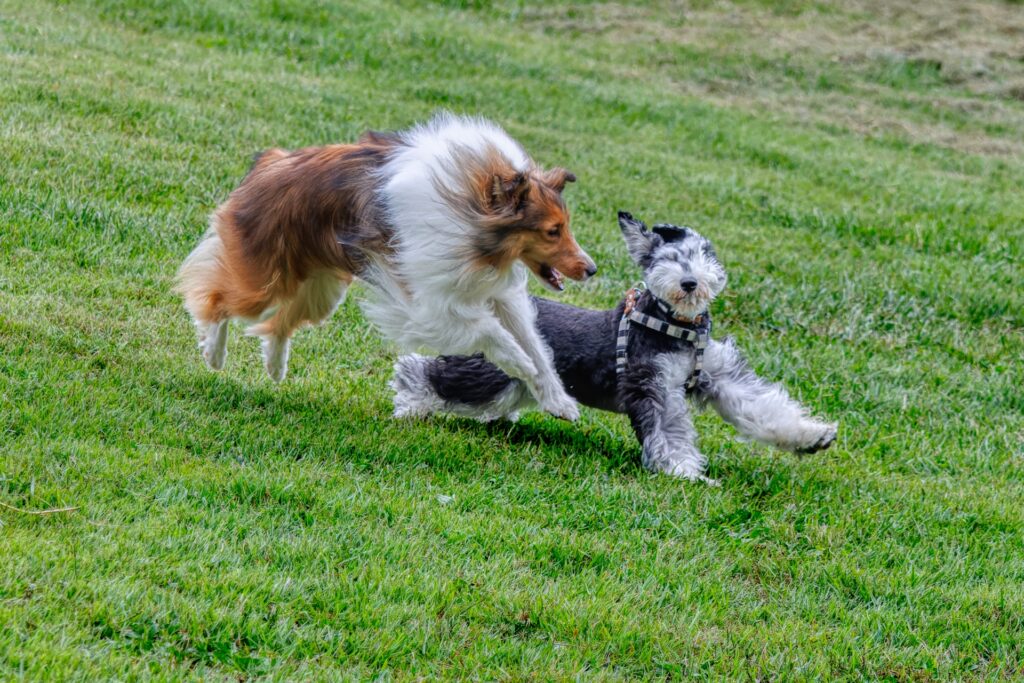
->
178, 133, 398, 322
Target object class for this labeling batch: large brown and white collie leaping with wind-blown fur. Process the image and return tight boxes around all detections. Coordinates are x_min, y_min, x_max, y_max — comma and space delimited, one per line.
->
176, 113, 597, 420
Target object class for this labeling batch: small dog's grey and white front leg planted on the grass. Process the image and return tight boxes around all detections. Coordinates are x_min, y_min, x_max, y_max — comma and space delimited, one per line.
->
626, 384, 718, 485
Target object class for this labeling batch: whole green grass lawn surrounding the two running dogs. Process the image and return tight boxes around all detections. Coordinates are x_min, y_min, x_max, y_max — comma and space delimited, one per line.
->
0, 0, 1024, 681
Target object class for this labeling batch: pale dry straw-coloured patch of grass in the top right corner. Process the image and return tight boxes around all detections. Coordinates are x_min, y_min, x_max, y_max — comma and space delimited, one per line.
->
524, 0, 1024, 155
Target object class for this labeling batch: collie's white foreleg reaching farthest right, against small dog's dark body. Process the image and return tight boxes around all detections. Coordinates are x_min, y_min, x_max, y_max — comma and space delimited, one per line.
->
495, 293, 580, 421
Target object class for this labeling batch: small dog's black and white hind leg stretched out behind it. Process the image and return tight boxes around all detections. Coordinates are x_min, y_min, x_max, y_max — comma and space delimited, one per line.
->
391, 353, 534, 422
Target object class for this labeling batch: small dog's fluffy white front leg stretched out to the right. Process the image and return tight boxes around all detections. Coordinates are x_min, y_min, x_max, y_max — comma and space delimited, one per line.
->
697, 339, 836, 453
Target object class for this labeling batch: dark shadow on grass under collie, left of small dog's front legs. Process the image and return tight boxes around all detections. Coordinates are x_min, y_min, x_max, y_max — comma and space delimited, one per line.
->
158, 372, 640, 476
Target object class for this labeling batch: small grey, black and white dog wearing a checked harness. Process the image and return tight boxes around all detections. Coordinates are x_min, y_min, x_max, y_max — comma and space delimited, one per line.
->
391, 213, 836, 483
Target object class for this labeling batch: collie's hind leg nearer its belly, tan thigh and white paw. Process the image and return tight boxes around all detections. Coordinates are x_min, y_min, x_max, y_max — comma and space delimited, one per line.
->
247, 270, 351, 382
